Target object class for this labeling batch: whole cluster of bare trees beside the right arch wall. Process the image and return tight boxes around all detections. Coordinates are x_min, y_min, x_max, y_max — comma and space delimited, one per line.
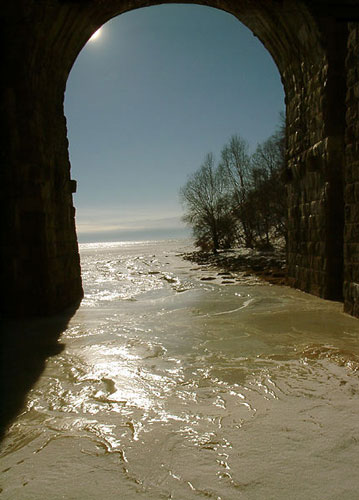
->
180, 115, 287, 252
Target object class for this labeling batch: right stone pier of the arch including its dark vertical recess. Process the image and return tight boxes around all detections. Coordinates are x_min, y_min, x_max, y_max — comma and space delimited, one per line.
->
286, 21, 347, 300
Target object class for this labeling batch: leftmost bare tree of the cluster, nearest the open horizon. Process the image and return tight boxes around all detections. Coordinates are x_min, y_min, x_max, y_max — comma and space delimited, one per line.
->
180, 153, 234, 253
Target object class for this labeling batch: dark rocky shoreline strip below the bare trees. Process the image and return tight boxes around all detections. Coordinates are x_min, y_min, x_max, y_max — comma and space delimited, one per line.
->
180, 248, 288, 286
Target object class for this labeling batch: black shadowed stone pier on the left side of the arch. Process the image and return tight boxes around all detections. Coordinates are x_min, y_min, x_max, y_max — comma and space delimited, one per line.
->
0, 7, 82, 316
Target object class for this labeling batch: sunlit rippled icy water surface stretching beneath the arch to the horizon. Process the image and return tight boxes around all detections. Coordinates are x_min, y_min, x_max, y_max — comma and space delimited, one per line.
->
0, 241, 359, 500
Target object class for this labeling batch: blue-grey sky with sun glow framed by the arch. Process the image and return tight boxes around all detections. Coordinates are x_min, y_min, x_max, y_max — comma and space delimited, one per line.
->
65, 5, 284, 241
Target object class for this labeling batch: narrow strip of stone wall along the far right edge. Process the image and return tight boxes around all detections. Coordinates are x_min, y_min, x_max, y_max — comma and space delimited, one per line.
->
344, 23, 359, 317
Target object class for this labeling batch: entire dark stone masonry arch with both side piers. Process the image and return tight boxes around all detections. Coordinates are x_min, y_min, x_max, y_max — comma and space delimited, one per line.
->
0, 0, 359, 316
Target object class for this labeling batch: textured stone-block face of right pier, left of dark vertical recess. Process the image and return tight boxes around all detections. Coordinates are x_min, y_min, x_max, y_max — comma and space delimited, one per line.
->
286, 56, 334, 297
